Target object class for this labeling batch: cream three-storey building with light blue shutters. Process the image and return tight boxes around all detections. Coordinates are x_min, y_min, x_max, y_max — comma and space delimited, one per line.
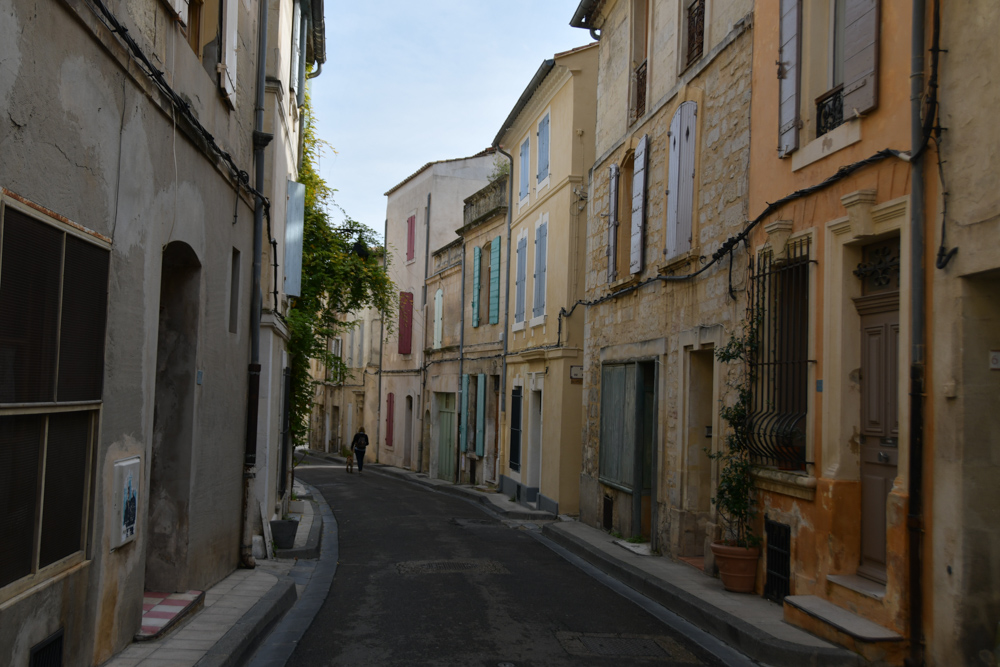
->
494, 44, 598, 514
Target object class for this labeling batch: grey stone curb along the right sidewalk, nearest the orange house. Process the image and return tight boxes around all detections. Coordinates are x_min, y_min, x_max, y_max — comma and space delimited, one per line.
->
542, 523, 867, 667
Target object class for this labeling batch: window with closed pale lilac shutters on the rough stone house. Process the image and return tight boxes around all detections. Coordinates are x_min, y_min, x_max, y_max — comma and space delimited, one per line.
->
664, 102, 698, 259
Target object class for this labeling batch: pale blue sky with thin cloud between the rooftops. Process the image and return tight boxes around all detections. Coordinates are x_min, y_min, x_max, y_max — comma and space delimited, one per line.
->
310, 0, 593, 238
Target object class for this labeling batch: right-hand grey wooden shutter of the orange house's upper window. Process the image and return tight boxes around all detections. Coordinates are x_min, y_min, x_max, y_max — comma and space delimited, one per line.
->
844, 0, 879, 120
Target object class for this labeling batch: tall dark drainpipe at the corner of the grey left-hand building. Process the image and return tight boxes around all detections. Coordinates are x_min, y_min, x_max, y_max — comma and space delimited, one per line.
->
240, 0, 278, 568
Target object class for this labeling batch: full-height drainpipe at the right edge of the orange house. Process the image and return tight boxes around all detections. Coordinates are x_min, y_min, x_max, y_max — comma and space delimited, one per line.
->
906, 0, 934, 667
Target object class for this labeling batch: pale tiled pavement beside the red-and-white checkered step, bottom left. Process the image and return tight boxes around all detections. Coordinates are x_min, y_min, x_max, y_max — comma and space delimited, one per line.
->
104, 569, 283, 667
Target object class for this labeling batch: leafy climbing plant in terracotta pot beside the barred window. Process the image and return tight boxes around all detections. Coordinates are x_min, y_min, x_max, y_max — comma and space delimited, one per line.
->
706, 317, 761, 593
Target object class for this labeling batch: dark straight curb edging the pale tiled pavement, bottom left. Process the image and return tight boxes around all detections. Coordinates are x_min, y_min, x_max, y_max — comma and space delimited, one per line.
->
195, 577, 296, 667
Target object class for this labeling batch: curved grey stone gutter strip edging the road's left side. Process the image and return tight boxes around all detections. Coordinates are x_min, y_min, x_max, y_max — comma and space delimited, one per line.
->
247, 480, 340, 667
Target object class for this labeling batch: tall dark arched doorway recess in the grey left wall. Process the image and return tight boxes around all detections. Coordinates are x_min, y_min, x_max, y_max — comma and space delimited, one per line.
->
145, 241, 201, 593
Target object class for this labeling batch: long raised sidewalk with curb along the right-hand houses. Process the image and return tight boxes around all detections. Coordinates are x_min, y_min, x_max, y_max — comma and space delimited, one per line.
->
310, 452, 867, 667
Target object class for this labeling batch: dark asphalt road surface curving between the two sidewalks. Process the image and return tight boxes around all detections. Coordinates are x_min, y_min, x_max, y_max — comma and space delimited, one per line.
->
288, 460, 736, 667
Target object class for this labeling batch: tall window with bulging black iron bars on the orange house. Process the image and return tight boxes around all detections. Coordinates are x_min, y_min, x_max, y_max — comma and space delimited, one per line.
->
748, 238, 809, 470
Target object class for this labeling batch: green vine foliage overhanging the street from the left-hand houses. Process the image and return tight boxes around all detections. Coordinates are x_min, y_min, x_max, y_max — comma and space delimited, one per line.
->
287, 95, 396, 445
